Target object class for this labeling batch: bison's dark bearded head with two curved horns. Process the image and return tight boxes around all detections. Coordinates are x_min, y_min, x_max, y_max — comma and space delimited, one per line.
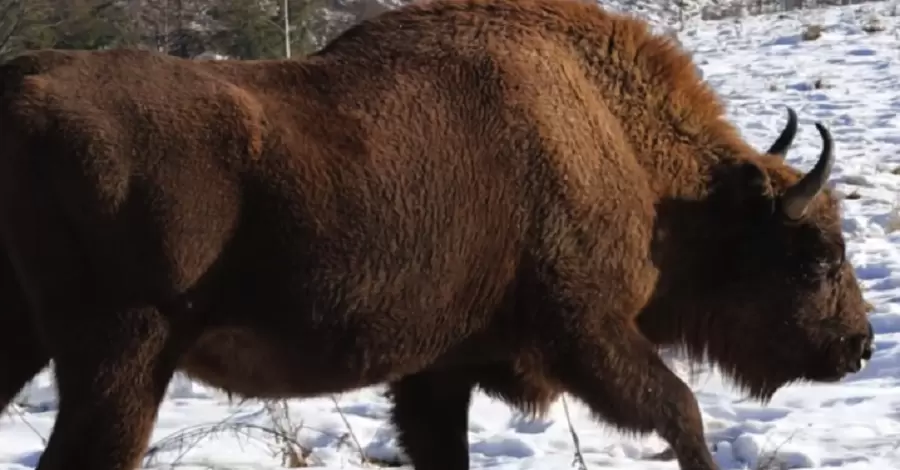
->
641, 110, 873, 399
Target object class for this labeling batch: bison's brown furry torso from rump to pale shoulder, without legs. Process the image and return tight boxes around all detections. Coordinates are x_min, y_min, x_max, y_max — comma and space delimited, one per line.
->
0, 0, 652, 388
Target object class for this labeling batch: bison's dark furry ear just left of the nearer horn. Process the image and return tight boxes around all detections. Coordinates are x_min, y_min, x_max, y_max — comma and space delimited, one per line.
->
715, 161, 775, 216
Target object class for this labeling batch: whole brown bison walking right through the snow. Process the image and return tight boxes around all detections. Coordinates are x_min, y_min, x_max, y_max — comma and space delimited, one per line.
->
0, 0, 872, 470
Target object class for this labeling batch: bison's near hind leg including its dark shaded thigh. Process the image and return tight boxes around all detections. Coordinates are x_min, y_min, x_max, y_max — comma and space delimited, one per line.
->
0, 170, 194, 470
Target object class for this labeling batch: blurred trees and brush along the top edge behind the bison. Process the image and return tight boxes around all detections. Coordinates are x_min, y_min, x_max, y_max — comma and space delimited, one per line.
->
0, 0, 884, 60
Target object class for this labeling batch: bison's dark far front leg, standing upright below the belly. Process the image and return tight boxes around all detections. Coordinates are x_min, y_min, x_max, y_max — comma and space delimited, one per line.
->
390, 370, 474, 470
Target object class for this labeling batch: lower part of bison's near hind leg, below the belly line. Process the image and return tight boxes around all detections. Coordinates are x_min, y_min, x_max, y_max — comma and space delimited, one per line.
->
38, 308, 186, 470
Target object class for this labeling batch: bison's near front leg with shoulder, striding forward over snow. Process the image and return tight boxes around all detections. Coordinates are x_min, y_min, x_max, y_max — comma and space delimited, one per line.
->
529, 190, 716, 470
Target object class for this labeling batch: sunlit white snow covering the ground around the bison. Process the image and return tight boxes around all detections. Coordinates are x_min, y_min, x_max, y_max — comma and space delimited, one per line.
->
0, 3, 900, 470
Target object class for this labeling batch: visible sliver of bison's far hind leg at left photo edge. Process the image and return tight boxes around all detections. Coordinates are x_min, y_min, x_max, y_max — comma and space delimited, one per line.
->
0, 253, 50, 413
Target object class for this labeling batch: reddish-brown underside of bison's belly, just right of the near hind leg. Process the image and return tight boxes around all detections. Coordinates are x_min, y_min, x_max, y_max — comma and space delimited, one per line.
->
179, 328, 400, 398
